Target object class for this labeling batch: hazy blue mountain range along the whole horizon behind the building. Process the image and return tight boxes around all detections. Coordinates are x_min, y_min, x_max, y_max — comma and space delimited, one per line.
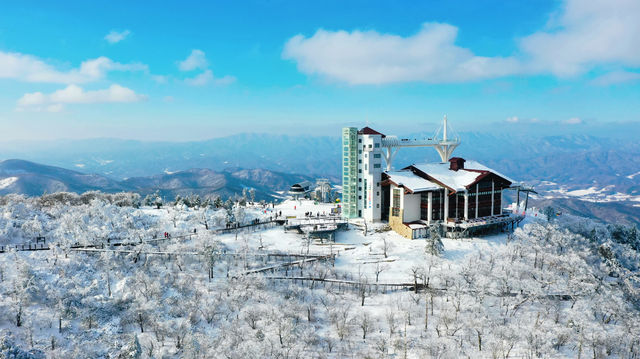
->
0, 131, 640, 223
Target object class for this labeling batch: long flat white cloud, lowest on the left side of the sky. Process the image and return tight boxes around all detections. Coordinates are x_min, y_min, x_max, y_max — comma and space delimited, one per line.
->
17, 85, 147, 112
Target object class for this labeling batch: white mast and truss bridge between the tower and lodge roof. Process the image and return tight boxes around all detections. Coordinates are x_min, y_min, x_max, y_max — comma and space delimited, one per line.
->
382, 115, 460, 171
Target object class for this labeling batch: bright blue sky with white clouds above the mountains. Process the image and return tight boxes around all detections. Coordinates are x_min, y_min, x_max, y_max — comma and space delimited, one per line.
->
0, 0, 640, 141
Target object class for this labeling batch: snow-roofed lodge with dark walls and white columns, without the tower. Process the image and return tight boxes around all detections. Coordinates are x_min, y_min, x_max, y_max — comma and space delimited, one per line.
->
381, 157, 513, 238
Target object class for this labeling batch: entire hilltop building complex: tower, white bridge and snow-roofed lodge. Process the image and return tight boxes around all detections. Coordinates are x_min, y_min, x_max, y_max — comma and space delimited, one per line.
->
342, 123, 522, 239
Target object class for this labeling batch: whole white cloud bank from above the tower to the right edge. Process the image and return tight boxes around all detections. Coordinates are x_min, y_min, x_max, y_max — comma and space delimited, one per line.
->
282, 0, 640, 84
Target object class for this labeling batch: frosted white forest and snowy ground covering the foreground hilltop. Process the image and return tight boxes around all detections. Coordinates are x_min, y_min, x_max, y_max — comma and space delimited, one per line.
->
0, 192, 640, 358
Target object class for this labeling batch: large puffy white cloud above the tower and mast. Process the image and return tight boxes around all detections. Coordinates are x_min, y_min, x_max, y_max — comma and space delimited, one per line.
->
282, 23, 519, 84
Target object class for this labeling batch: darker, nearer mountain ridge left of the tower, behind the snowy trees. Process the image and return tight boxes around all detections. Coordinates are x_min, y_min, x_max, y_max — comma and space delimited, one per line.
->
0, 159, 312, 200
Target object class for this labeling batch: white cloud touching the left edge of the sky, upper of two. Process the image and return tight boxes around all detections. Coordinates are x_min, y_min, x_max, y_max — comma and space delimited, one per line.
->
0, 51, 148, 84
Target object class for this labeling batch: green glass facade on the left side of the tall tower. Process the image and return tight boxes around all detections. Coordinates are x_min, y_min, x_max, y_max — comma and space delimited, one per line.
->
342, 127, 358, 218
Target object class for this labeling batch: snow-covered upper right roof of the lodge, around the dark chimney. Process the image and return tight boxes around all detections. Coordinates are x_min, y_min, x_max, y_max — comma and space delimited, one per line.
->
413, 160, 514, 191
